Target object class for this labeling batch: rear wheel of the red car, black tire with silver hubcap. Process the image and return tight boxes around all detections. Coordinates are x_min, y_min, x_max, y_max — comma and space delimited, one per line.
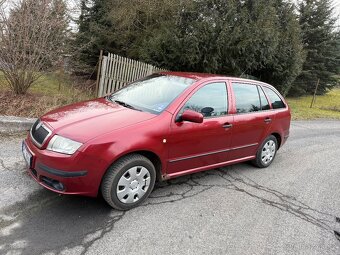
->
251, 135, 278, 168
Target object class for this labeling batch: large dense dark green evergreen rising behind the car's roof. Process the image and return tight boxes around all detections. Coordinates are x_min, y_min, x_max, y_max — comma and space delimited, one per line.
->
142, 0, 303, 94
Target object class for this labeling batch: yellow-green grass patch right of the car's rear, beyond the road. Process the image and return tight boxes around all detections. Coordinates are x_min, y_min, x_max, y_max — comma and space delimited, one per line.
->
287, 88, 340, 120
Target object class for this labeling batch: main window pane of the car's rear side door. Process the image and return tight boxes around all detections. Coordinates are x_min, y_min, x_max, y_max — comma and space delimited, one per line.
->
233, 83, 261, 113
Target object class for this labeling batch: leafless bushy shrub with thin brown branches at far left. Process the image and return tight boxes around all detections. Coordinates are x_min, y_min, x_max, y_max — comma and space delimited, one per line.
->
0, 0, 67, 94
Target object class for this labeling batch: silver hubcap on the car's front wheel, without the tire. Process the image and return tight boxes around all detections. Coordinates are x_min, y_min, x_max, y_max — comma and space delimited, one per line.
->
117, 166, 151, 204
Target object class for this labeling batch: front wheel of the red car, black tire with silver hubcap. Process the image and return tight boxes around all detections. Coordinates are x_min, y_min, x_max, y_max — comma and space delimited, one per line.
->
101, 154, 156, 211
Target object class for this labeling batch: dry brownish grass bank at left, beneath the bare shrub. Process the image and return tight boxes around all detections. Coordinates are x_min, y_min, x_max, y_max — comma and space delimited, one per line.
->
0, 73, 94, 117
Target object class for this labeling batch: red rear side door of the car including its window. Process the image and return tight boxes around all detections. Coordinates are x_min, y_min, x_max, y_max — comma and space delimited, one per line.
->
230, 81, 275, 160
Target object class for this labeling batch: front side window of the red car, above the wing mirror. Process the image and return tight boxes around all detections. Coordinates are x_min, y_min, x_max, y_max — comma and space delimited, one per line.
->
180, 82, 228, 118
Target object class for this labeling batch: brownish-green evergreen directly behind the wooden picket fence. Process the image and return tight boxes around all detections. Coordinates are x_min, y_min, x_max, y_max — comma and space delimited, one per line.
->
73, 0, 183, 73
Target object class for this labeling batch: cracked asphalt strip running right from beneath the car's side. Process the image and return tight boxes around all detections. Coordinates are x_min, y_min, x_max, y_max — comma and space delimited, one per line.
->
144, 166, 340, 236
